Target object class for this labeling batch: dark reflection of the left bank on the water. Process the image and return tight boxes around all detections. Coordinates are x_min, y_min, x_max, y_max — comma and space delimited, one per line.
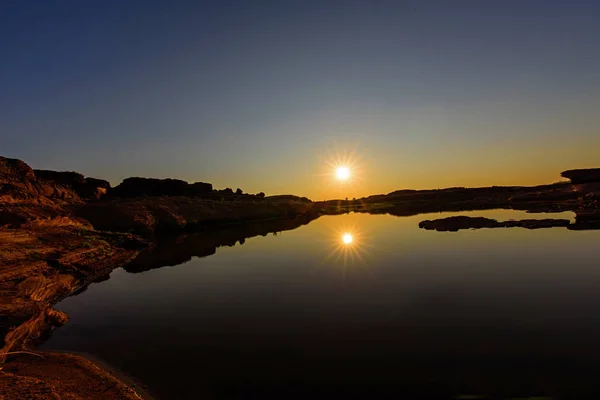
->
124, 216, 315, 273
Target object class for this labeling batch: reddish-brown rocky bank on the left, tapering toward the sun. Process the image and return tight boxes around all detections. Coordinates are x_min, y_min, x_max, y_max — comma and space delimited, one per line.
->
0, 157, 318, 399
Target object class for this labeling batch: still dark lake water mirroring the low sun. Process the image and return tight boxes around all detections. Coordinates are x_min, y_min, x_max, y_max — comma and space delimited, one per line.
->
44, 211, 600, 399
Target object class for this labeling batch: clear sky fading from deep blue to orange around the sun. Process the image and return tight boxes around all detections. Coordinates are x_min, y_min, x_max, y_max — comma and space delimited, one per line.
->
0, 0, 600, 199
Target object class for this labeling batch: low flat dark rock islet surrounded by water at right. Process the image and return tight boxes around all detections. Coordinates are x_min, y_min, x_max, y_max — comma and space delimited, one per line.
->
419, 216, 570, 232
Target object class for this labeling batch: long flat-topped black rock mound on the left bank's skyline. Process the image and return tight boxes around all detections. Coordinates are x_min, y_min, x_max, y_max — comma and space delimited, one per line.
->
111, 178, 212, 197
